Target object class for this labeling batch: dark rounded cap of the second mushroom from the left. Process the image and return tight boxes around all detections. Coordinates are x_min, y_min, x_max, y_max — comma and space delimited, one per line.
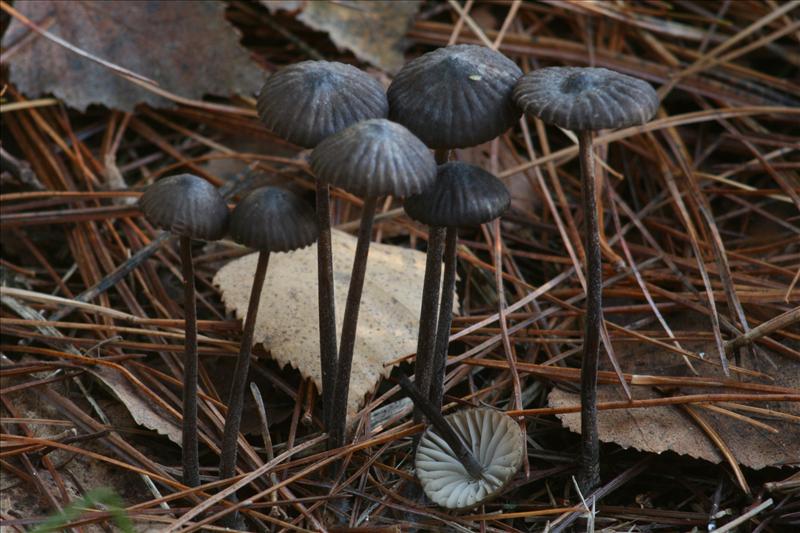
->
230, 187, 318, 252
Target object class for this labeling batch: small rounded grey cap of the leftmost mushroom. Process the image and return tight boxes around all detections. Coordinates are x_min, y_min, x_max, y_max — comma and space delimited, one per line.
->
139, 174, 228, 241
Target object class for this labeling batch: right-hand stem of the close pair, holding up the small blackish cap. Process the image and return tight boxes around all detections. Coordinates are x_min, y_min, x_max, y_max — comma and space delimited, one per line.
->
428, 227, 458, 410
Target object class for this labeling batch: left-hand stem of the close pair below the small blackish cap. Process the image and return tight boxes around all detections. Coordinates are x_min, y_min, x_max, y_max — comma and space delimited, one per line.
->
414, 226, 445, 422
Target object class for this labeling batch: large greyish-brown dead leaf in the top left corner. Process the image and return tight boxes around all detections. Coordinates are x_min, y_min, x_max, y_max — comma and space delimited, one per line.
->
2, 0, 262, 111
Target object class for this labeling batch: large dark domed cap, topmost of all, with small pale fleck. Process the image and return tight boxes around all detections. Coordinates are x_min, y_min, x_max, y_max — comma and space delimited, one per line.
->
387, 44, 522, 148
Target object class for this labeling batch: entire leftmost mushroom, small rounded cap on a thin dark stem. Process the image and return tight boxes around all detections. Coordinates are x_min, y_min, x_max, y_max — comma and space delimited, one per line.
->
139, 174, 228, 487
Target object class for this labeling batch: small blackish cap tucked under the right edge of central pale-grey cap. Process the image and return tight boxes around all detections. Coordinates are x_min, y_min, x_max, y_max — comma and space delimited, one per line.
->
404, 161, 511, 227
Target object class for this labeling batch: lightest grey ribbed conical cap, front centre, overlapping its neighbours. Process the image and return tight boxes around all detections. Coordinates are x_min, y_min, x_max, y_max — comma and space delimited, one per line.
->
311, 119, 436, 198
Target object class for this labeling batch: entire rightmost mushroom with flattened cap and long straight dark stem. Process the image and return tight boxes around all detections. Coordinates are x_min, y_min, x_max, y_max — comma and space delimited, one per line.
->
514, 67, 658, 491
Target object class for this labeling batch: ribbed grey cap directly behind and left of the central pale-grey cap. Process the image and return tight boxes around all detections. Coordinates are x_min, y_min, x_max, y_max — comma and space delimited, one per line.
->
257, 61, 389, 148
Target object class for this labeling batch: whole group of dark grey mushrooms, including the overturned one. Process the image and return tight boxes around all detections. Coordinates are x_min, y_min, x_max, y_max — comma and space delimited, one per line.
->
140, 45, 658, 509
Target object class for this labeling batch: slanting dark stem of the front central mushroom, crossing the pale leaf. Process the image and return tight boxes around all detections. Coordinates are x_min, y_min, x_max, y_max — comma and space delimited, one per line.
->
328, 196, 378, 448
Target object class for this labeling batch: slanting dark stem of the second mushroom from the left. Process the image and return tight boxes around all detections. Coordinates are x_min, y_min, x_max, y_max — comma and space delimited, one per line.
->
219, 252, 269, 479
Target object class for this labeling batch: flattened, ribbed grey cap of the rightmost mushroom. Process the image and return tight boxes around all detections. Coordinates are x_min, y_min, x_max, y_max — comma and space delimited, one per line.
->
514, 67, 658, 131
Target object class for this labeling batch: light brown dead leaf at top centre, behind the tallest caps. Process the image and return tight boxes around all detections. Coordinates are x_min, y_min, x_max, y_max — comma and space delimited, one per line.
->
278, 0, 422, 72
